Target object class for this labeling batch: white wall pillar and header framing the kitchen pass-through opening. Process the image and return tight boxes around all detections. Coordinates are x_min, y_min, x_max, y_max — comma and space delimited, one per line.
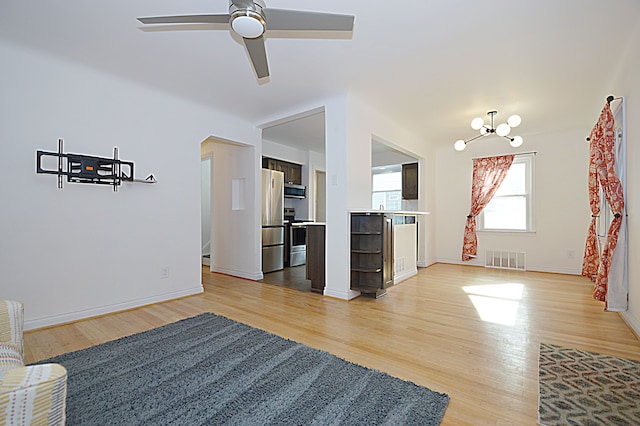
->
324, 94, 435, 299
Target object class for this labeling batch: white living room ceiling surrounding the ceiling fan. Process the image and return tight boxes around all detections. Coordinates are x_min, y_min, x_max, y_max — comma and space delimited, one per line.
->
0, 0, 640, 153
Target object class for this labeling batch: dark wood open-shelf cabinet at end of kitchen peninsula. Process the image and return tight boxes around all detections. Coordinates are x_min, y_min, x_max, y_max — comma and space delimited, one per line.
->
351, 212, 394, 298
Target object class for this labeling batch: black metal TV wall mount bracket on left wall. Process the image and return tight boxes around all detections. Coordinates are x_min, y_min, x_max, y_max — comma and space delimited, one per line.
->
36, 139, 157, 191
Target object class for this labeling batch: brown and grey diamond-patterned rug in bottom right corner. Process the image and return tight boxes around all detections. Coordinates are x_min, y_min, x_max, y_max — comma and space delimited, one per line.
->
538, 343, 640, 426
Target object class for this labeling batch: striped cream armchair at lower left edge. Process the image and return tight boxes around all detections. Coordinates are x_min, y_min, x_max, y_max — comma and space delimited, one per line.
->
0, 300, 67, 425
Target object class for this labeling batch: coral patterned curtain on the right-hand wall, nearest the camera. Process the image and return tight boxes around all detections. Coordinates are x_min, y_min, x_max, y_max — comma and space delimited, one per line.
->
582, 102, 624, 310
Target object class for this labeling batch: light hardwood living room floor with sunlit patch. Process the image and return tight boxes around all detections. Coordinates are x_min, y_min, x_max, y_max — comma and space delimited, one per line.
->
25, 264, 640, 425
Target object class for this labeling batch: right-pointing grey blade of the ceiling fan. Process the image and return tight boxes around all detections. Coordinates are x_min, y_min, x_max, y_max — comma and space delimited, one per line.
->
264, 9, 355, 31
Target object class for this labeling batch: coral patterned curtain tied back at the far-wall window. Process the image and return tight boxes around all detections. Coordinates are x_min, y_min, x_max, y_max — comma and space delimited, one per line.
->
462, 154, 515, 260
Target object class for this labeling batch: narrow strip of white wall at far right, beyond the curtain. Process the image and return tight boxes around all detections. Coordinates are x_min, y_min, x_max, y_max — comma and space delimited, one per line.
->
612, 24, 640, 336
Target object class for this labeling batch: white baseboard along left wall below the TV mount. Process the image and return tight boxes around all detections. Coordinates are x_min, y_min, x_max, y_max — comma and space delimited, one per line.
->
24, 284, 204, 330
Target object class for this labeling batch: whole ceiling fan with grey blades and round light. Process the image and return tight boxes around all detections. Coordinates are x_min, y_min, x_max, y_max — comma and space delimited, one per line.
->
138, 0, 354, 78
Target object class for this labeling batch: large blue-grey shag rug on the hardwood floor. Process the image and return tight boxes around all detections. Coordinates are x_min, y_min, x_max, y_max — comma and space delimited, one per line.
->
41, 313, 449, 425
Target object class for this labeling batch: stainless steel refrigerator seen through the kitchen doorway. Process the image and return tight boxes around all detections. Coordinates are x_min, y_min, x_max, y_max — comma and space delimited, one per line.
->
262, 169, 284, 273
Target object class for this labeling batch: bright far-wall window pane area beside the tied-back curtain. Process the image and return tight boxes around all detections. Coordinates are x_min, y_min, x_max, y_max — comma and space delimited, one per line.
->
478, 154, 534, 232
